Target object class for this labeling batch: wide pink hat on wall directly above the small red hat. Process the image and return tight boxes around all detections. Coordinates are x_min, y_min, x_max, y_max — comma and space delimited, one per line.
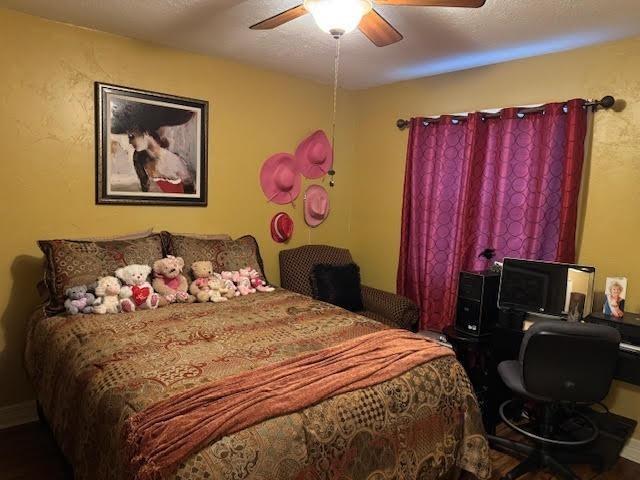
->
260, 153, 302, 205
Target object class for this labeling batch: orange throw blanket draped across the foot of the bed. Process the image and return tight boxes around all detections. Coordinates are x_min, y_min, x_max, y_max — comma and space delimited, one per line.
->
124, 329, 453, 480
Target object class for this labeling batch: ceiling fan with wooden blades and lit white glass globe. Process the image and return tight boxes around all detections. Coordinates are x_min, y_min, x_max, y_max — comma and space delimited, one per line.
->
249, 0, 486, 47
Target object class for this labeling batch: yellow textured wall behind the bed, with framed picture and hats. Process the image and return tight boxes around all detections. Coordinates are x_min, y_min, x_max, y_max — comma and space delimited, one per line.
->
0, 9, 353, 406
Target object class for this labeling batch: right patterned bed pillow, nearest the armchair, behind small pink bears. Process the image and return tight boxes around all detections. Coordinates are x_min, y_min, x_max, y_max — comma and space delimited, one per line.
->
163, 232, 266, 280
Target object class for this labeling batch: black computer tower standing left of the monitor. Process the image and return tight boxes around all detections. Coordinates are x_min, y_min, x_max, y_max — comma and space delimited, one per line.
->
455, 271, 500, 336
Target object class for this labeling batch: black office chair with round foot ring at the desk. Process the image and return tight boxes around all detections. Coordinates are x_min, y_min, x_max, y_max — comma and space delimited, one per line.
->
489, 320, 620, 480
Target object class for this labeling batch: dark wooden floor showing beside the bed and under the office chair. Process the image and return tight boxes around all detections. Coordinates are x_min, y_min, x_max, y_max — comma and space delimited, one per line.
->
0, 423, 640, 480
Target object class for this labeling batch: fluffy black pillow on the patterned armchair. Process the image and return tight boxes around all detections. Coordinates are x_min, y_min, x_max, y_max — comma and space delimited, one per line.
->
310, 263, 364, 312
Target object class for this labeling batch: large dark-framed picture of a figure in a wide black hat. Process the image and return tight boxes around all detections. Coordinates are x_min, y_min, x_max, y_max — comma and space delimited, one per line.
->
95, 82, 209, 206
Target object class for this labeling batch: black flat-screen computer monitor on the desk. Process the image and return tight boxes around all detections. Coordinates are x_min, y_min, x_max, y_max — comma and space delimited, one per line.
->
498, 258, 596, 320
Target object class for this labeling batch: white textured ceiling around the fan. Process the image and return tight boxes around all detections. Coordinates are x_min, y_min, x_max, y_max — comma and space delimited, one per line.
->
0, 0, 640, 88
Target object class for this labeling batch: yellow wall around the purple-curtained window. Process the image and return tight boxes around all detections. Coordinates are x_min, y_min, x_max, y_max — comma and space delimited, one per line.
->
351, 37, 640, 437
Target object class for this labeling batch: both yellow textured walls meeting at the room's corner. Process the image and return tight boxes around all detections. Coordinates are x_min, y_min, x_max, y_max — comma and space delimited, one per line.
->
0, 5, 640, 436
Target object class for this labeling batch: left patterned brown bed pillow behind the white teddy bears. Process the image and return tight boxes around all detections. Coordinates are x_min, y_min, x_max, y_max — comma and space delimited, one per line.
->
38, 234, 163, 315
